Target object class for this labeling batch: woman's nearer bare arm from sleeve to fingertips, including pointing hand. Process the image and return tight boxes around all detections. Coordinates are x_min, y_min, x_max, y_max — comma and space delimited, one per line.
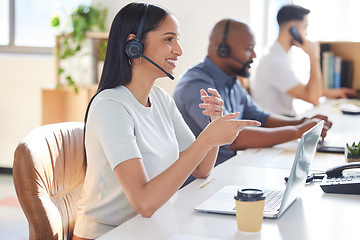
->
114, 113, 260, 217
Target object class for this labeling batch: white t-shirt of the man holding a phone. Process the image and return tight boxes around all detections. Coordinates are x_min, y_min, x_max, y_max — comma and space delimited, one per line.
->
251, 41, 301, 116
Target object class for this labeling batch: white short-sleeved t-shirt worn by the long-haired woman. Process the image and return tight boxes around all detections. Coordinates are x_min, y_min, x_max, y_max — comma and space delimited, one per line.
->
74, 86, 195, 238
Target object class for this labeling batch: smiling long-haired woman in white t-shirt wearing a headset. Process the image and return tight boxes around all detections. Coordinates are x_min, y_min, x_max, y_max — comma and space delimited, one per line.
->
73, 3, 259, 239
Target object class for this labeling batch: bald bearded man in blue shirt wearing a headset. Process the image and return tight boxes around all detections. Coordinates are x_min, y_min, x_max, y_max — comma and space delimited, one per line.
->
173, 19, 331, 167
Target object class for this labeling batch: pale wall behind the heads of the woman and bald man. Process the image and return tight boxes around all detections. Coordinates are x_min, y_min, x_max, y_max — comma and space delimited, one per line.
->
93, 0, 268, 94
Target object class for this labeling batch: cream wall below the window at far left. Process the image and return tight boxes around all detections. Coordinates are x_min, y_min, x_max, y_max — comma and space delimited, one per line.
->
0, 54, 55, 167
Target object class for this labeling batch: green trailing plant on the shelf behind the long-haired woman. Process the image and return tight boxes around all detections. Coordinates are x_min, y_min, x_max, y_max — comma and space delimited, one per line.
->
51, 5, 107, 93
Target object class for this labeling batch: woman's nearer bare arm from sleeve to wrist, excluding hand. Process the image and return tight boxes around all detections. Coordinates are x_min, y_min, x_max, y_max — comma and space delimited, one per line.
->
114, 129, 210, 217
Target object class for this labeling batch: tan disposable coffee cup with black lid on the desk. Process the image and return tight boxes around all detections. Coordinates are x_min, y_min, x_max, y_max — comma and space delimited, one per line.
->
234, 188, 265, 232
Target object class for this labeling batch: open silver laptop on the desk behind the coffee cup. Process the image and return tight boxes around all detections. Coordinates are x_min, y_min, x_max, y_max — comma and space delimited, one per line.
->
195, 121, 324, 218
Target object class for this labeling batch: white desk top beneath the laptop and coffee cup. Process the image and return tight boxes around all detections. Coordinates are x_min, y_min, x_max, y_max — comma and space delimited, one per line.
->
99, 100, 360, 240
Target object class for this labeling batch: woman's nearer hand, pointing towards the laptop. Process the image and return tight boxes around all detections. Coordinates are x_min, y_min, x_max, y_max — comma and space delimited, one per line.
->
198, 113, 261, 147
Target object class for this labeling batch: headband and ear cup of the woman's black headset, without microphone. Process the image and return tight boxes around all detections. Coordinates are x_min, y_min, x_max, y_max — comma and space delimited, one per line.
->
125, 5, 148, 59
